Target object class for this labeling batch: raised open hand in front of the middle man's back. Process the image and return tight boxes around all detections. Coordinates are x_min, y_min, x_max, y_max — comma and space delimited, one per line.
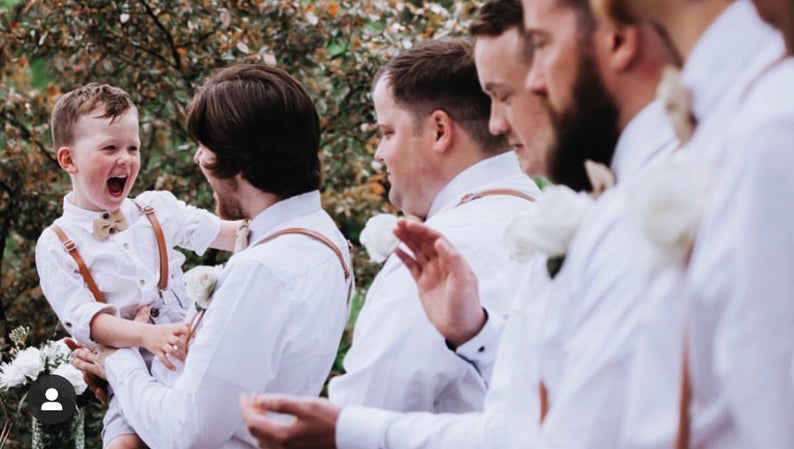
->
394, 220, 486, 347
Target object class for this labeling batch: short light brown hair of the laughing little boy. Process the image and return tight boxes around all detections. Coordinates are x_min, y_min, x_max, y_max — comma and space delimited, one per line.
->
50, 83, 136, 149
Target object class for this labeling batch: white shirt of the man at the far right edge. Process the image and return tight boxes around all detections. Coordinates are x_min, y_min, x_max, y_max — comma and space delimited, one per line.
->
686, 7, 794, 448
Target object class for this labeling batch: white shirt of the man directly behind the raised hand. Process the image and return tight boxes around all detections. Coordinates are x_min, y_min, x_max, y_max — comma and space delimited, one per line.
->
329, 152, 540, 412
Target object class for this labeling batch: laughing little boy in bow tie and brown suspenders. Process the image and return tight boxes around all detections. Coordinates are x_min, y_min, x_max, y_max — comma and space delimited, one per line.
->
36, 84, 238, 449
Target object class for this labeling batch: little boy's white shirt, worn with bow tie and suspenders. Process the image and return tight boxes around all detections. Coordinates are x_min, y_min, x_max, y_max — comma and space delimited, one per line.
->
36, 192, 220, 342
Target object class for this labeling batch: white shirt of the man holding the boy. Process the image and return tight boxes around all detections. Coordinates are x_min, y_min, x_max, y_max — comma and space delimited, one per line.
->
105, 191, 350, 449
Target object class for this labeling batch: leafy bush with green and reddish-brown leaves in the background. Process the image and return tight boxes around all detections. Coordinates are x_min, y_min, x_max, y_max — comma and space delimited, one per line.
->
0, 0, 478, 440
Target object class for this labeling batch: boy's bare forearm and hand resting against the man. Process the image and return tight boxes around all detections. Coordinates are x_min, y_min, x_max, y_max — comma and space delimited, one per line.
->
91, 313, 188, 370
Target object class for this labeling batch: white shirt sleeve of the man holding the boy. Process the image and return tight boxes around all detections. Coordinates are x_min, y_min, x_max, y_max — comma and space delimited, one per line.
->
105, 260, 294, 449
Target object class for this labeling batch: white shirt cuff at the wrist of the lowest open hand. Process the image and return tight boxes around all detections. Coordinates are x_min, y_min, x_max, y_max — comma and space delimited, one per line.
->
336, 406, 397, 449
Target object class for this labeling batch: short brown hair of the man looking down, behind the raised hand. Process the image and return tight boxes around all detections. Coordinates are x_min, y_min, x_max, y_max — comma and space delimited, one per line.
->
373, 39, 506, 153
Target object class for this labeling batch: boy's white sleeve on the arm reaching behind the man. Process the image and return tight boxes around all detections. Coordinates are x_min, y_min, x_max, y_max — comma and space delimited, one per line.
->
136, 191, 221, 255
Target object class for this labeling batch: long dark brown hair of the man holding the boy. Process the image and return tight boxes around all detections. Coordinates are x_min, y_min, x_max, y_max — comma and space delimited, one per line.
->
187, 64, 321, 198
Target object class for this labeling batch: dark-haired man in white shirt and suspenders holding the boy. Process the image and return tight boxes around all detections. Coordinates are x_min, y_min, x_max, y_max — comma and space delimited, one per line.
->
76, 65, 352, 448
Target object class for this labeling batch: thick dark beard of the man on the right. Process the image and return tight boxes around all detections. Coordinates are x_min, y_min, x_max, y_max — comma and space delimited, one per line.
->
548, 51, 620, 191
